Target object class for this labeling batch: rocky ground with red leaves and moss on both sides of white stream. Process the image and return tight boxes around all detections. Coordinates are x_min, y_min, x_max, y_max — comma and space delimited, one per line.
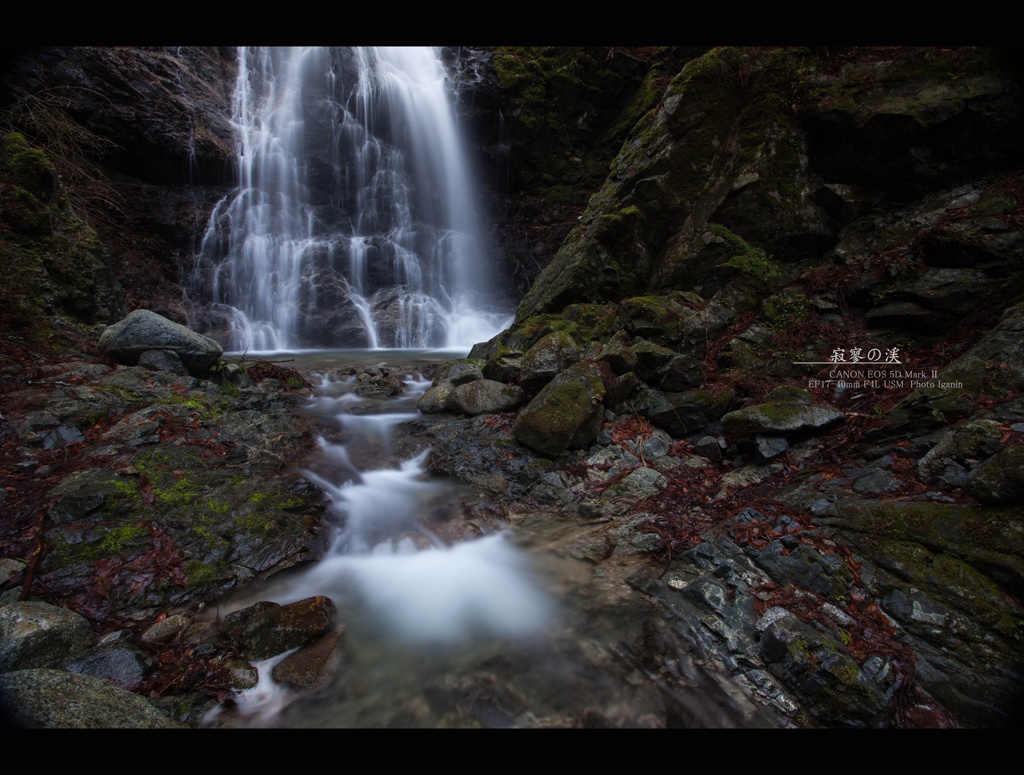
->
0, 315, 1024, 728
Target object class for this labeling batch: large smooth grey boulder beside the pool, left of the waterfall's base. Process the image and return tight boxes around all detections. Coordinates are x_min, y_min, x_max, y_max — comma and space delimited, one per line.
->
99, 309, 224, 376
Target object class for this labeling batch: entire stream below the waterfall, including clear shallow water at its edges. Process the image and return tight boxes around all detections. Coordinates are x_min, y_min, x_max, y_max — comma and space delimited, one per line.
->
201, 350, 774, 728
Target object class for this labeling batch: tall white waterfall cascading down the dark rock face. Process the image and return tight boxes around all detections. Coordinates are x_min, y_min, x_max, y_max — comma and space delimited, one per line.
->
189, 47, 511, 351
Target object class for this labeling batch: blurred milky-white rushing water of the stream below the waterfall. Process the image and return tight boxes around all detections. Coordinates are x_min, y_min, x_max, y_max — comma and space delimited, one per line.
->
206, 362, 558, 727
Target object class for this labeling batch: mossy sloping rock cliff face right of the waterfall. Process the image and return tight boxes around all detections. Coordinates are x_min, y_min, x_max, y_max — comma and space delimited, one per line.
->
518, 48, 1021, 320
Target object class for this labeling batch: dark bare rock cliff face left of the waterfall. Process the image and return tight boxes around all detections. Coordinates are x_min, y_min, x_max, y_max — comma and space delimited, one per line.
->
0, 47, 234, 322
